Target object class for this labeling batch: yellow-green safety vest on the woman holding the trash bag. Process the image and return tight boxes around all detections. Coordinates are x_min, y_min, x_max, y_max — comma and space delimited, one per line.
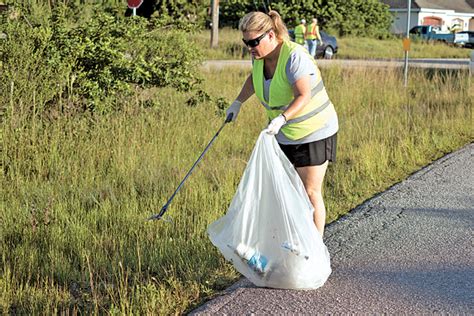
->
252, 41, 336, 140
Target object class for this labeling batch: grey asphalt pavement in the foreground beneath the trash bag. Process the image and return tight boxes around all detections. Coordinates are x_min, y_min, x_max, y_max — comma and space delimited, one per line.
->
191, 143, 474, 315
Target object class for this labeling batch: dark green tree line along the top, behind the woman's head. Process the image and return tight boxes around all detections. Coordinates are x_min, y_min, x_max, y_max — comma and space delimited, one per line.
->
29, 0, 392, 37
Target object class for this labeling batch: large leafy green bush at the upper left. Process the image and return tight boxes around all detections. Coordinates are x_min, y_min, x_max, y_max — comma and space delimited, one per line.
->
0, 5, 202, 113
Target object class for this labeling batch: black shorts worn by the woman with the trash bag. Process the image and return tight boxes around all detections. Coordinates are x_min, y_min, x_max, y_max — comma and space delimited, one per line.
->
279, 134, 337, 167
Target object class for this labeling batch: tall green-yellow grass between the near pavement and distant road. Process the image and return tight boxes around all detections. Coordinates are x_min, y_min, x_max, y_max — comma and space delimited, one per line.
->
0, 68, 474, 314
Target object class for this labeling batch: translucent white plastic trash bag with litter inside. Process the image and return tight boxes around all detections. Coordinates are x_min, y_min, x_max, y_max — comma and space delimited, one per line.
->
208, 132, 331, 289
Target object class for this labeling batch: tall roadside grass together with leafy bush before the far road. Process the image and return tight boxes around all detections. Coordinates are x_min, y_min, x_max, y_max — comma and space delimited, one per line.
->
0, 1, 474, 315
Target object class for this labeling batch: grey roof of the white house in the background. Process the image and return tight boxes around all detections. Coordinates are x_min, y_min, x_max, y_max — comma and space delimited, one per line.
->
382, 0, 474, 13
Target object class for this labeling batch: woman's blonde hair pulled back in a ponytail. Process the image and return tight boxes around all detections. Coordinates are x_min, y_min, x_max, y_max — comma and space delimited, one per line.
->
239, 10, 289, 42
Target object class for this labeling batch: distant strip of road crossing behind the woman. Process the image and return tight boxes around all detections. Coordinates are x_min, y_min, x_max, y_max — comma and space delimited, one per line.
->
202, 58, 470, 70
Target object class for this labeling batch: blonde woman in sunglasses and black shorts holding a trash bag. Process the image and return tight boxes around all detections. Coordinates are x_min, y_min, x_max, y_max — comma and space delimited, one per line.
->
226, 11, 338, 236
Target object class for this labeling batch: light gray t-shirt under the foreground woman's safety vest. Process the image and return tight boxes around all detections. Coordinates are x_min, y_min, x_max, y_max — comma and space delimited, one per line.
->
263, 47, 339, 145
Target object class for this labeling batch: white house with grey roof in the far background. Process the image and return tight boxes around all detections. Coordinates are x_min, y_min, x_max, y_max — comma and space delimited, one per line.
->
381, 0, 474, 34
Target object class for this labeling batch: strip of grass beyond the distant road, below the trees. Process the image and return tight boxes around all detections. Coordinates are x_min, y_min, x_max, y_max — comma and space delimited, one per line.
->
195, 28, 471, 59
